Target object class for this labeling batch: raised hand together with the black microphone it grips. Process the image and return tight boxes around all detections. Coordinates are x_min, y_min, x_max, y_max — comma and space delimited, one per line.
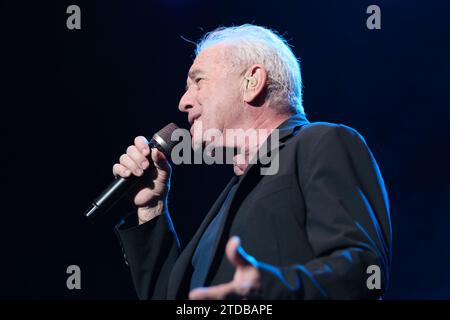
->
85, 123, 178, 224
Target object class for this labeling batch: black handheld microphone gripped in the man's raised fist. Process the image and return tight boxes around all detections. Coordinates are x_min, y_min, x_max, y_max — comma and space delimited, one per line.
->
84, 123, 178, 221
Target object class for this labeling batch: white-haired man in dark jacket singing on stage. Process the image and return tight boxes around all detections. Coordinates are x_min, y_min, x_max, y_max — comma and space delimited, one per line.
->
113, 25, 391, 299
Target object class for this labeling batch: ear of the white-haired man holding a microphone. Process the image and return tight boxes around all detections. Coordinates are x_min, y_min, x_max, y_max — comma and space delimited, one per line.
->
243, 64, 267, 104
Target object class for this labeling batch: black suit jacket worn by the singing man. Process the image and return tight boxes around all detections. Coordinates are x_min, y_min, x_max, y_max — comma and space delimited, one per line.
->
117, 115, 391, 299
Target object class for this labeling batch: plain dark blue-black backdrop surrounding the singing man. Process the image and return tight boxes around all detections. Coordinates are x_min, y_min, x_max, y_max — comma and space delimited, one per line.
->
0, 0, 450, 299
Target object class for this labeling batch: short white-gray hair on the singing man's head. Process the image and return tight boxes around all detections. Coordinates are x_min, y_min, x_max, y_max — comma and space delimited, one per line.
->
195, 24, 304, 114
